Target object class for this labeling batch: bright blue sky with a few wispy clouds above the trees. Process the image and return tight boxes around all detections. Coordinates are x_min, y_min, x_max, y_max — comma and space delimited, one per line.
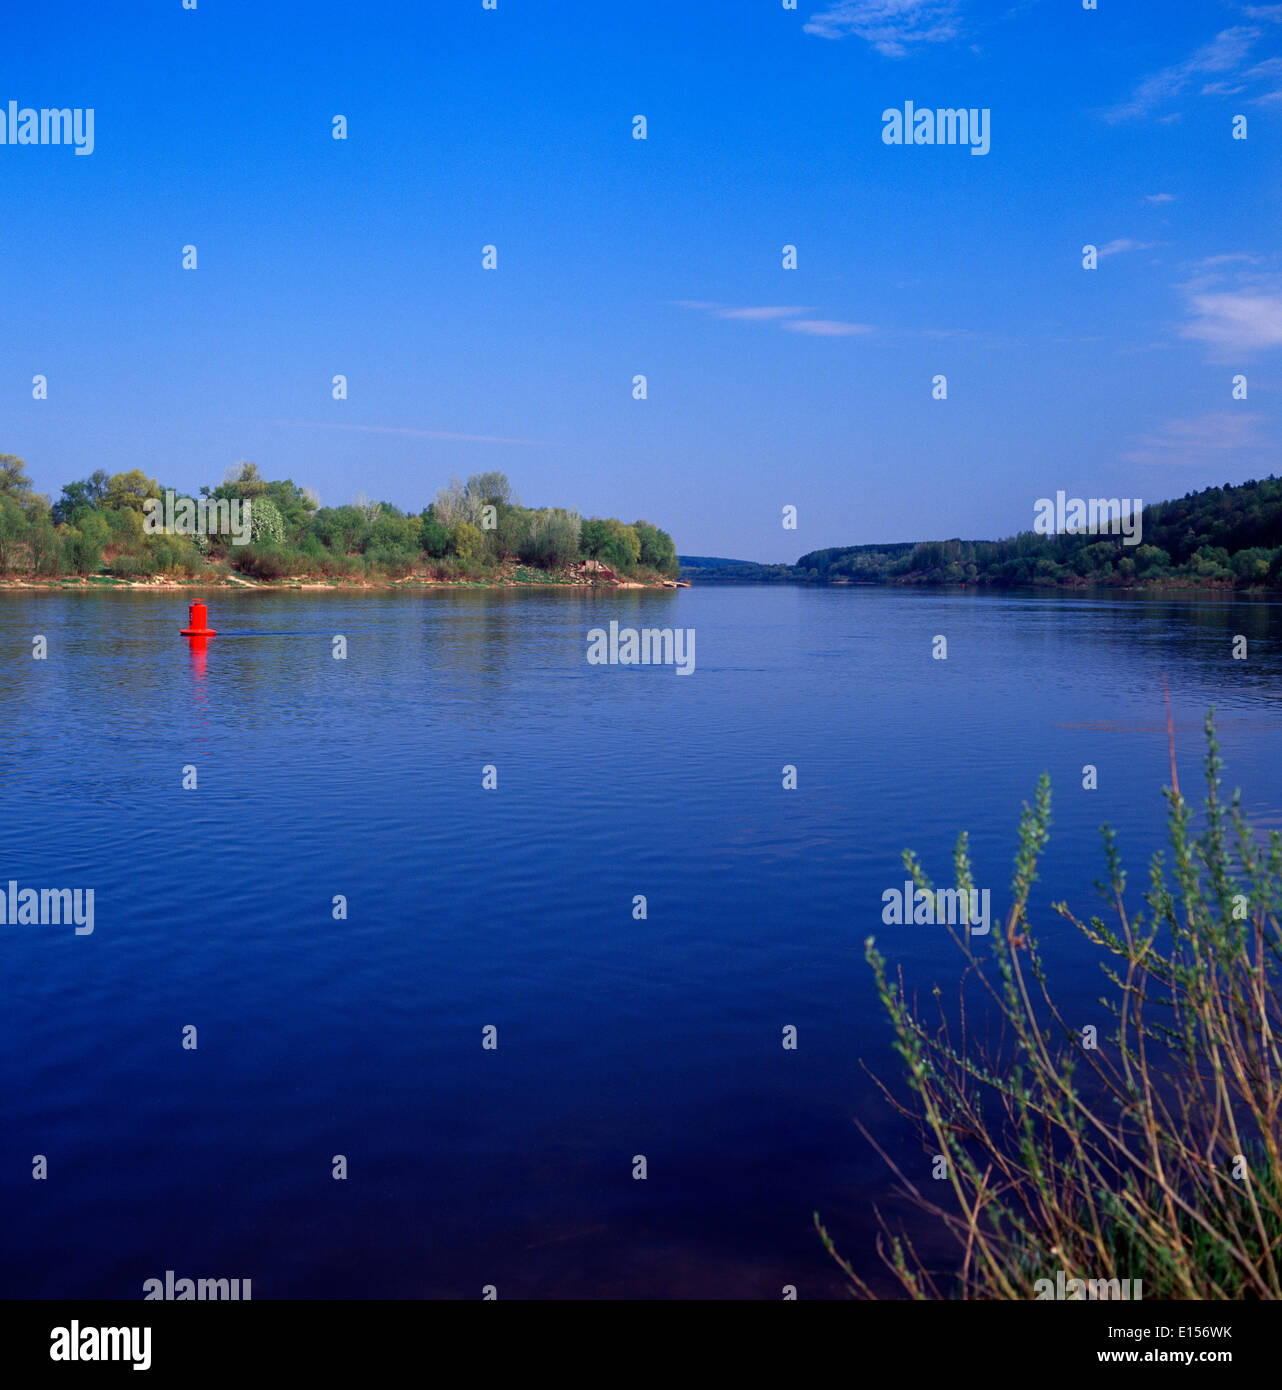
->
0, 0, 1282, 560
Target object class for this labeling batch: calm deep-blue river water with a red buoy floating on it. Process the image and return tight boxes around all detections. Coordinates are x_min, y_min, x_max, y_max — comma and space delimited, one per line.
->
0, 587, 1282, 1298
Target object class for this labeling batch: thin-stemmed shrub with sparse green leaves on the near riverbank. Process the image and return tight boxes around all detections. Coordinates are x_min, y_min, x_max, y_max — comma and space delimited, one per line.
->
816, 714, 1282, 1300
